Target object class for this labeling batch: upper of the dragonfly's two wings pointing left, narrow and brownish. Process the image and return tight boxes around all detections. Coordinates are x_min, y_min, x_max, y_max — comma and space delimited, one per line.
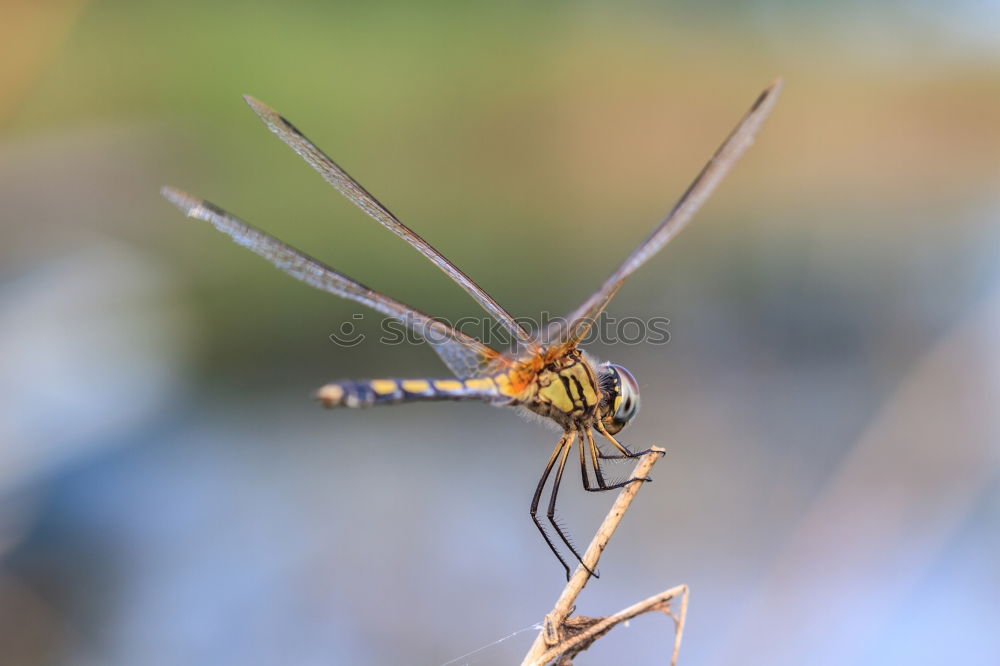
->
243, 95, 538, 351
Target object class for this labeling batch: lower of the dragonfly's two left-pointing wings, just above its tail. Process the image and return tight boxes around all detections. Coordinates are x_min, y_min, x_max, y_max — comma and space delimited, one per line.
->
161, 187, 510, 379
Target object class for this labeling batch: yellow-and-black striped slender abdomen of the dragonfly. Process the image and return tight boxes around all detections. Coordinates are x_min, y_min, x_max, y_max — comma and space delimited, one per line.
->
316, 377, 501, 407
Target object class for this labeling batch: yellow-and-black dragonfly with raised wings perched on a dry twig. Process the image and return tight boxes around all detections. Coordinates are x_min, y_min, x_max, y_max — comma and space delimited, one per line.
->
161, 79, 782, 579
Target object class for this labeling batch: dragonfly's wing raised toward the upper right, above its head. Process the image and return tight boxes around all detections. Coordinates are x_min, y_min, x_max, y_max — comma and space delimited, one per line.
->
548, 79, 781, 348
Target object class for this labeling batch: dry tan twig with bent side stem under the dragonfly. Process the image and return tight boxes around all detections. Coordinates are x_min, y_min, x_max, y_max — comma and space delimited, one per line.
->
521, 447, 688, 666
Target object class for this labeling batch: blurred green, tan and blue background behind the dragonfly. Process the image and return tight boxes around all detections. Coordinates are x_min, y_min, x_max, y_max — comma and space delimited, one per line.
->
0, 0, 1000, 666
